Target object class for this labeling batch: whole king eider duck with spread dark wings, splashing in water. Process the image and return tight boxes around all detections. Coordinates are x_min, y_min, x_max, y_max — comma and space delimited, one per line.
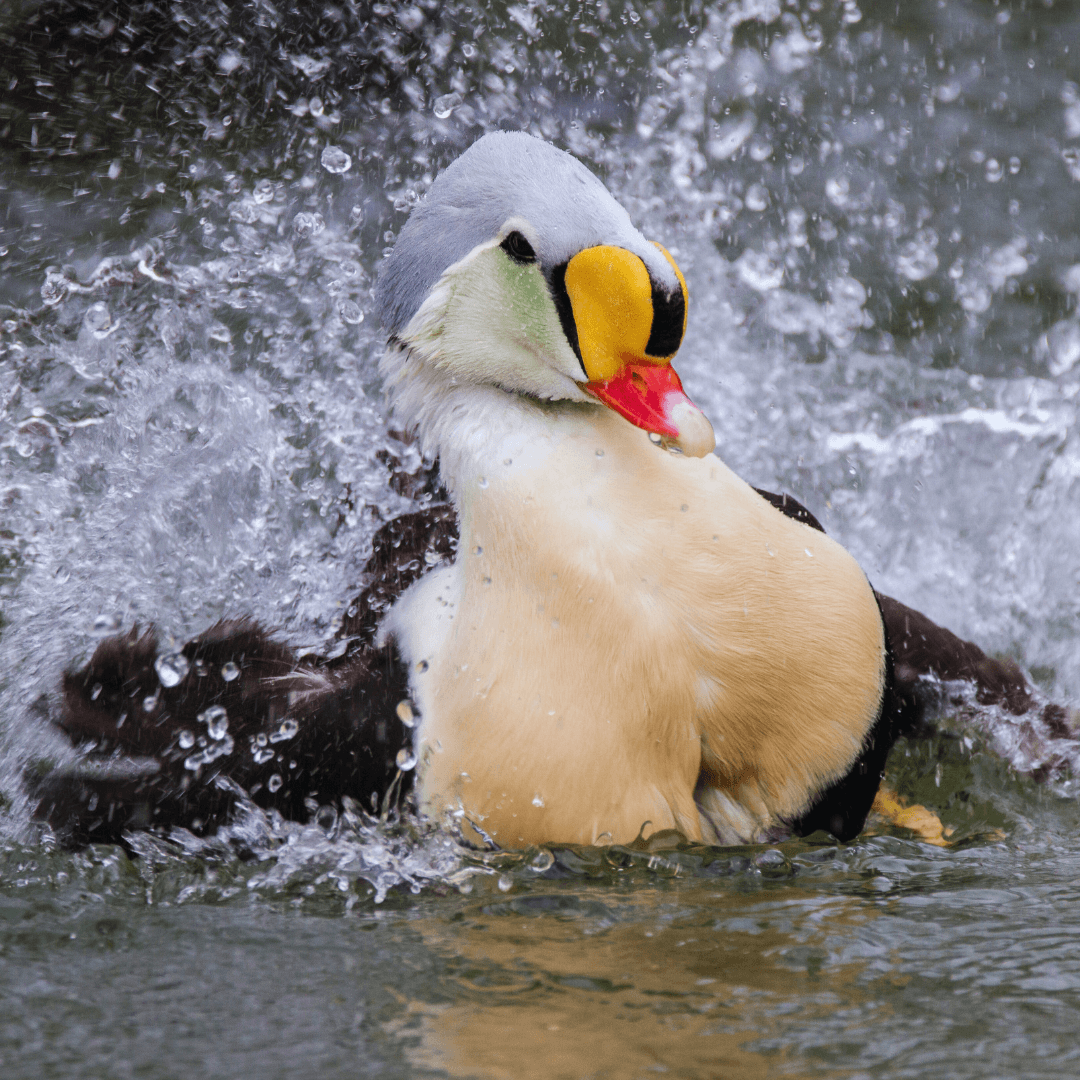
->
37, 133, 1045, 848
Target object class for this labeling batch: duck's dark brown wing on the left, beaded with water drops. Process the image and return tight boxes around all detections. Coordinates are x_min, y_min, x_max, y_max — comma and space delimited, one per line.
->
31, 505, 457, 845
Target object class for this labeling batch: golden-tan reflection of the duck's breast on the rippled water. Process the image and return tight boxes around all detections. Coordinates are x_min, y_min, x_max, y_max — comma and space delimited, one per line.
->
394, 886, 882, 1078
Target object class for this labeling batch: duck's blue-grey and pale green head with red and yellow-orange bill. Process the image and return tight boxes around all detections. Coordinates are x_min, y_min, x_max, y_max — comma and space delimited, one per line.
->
376, 132, 716, 457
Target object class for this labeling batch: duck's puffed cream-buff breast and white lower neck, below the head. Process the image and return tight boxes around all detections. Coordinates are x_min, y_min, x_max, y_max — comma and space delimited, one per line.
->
387, 407, 885, 847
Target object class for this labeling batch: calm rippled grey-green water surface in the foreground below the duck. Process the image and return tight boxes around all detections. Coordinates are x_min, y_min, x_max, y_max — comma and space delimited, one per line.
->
0, 820, 1080, 1077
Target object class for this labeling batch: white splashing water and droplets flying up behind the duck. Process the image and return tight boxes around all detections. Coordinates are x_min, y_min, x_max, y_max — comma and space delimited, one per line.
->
0, 0, 1080, 928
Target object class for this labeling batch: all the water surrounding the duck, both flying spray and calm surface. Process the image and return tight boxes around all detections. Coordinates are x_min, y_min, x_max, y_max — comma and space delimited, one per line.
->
0, 0, 1080, 1078
